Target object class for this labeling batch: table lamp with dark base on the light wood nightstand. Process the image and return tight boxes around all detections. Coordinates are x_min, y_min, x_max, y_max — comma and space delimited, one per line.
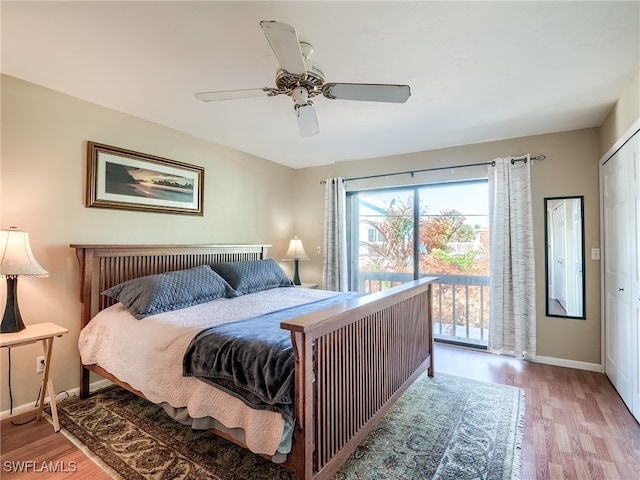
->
0, 227, 49, 333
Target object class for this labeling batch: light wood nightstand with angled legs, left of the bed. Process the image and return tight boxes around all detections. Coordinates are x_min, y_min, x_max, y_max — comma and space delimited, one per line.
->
0, 323, 69, 432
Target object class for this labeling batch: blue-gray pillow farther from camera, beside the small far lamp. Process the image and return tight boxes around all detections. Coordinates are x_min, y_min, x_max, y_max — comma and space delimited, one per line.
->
211, 258, 295, 296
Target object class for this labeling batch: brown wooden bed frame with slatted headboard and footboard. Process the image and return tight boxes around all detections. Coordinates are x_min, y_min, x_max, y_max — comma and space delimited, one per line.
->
71, 244, 435, 479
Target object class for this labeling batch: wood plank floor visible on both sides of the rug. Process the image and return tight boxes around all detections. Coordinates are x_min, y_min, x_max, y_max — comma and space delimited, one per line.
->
0, 345, 640, 480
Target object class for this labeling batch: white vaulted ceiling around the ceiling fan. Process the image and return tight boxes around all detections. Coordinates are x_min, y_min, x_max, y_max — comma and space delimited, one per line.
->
1, 1, 640, 168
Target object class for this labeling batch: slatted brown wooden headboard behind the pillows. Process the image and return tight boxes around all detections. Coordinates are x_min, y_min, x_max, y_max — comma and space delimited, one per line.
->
71, 244, 271, 328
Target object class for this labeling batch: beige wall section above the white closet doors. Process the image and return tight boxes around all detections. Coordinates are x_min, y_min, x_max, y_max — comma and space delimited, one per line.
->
600, 70, 640, 156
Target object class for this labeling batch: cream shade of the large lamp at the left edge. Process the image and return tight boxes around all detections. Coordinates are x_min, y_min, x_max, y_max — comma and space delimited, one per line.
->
0, 227, 49, 278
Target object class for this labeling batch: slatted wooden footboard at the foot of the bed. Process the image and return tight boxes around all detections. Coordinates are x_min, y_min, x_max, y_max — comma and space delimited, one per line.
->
282, 278, 435, 479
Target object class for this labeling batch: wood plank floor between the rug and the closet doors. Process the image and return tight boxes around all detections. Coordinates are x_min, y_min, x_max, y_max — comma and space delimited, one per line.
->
435, 348, 640, 480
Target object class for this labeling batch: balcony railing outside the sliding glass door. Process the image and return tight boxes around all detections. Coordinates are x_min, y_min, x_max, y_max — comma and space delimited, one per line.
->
358, 272, 490, 347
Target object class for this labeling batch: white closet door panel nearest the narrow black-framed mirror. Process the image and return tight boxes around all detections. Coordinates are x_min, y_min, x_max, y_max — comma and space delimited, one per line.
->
603, 133, 638, 410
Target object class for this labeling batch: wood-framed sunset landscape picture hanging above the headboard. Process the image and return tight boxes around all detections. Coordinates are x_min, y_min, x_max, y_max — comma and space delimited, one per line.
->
87, 142, 204, 216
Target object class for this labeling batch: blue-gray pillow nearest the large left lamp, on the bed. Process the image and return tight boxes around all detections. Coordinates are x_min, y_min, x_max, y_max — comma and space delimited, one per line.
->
102, 265, 234, 319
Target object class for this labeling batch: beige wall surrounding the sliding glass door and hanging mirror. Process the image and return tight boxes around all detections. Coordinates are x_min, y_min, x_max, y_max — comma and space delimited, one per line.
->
296, 129, 600, 364
